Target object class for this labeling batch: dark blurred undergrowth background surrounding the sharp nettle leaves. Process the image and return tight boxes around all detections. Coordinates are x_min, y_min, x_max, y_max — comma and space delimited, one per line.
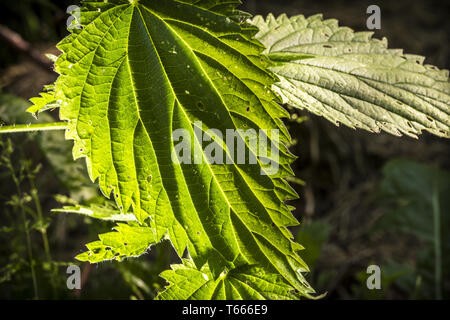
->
0, 0, 450, 299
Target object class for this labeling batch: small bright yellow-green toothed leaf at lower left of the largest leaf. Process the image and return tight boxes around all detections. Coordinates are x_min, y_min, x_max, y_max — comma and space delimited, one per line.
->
76, 223, 156, 263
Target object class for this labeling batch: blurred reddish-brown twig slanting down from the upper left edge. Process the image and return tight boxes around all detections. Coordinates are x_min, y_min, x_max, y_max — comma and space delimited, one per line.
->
0, 24, 53, 72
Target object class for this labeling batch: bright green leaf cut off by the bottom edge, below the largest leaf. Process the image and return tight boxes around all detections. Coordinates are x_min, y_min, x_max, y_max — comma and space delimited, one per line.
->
158, 260, 299, 300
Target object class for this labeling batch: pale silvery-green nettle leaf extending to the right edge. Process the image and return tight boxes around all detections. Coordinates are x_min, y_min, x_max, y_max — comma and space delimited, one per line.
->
251, 15, 450, 137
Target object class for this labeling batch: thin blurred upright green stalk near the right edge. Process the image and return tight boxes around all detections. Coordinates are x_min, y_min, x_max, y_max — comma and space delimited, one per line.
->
431, 183, 442, 300
